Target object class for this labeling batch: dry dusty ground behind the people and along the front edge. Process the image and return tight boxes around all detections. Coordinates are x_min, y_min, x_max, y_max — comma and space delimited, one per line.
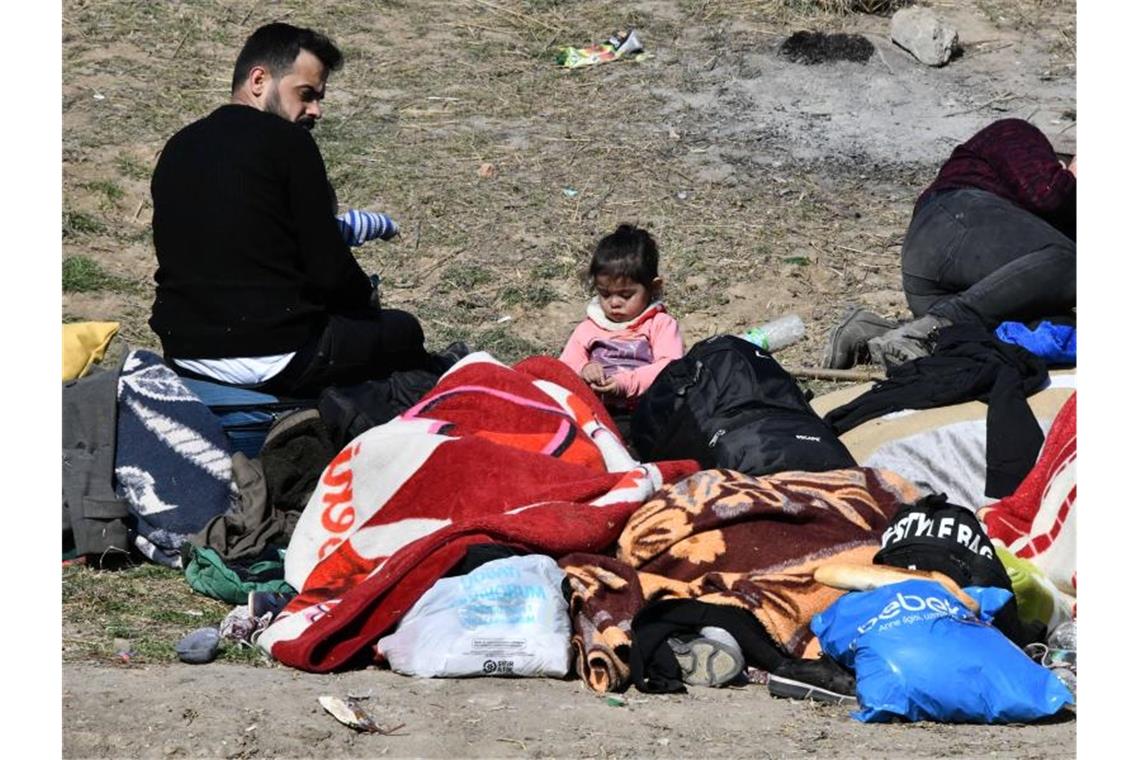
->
63, 0, 1076, 758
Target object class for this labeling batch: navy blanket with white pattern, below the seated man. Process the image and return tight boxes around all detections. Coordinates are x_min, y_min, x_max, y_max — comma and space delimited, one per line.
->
115, 350, 236, 567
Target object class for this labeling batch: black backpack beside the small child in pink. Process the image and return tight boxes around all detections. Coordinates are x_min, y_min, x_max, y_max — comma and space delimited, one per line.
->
630, 335, 855, 475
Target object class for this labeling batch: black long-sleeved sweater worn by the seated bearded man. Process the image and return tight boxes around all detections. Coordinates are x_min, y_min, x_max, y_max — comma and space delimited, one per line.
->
150, 105, 372, 359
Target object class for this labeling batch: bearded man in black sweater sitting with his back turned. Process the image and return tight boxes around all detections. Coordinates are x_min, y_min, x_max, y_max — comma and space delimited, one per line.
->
149, 23, 433, 397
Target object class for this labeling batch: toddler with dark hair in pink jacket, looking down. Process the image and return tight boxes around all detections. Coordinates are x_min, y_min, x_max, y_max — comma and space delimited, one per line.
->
560, 224, 684, 411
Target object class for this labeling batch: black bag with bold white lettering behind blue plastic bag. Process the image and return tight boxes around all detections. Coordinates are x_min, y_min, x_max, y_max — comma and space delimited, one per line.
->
873, 493, 1044, 646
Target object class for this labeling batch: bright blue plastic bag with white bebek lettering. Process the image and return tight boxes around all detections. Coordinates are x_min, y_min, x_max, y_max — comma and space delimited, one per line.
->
812, 580, 1075, 724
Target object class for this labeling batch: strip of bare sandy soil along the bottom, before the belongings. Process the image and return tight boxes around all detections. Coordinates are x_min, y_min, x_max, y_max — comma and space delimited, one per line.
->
64, 664, 1076, 759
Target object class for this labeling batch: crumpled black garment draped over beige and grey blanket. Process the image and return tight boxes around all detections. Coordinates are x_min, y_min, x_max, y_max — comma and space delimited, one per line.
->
824, 325, 1049, 498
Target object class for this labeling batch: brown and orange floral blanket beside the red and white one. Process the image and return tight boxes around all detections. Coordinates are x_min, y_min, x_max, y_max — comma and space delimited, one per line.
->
560, 467, 921, 692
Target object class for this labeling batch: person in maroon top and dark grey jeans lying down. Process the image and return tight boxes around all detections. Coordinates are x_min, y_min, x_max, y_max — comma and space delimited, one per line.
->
824, 119, 1076, 368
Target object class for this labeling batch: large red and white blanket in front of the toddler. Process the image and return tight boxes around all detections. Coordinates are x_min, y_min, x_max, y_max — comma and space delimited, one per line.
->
258, 353, 697, 672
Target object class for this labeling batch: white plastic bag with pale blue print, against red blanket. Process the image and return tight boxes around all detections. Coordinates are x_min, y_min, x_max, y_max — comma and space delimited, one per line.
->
376, 554, 570, 678
